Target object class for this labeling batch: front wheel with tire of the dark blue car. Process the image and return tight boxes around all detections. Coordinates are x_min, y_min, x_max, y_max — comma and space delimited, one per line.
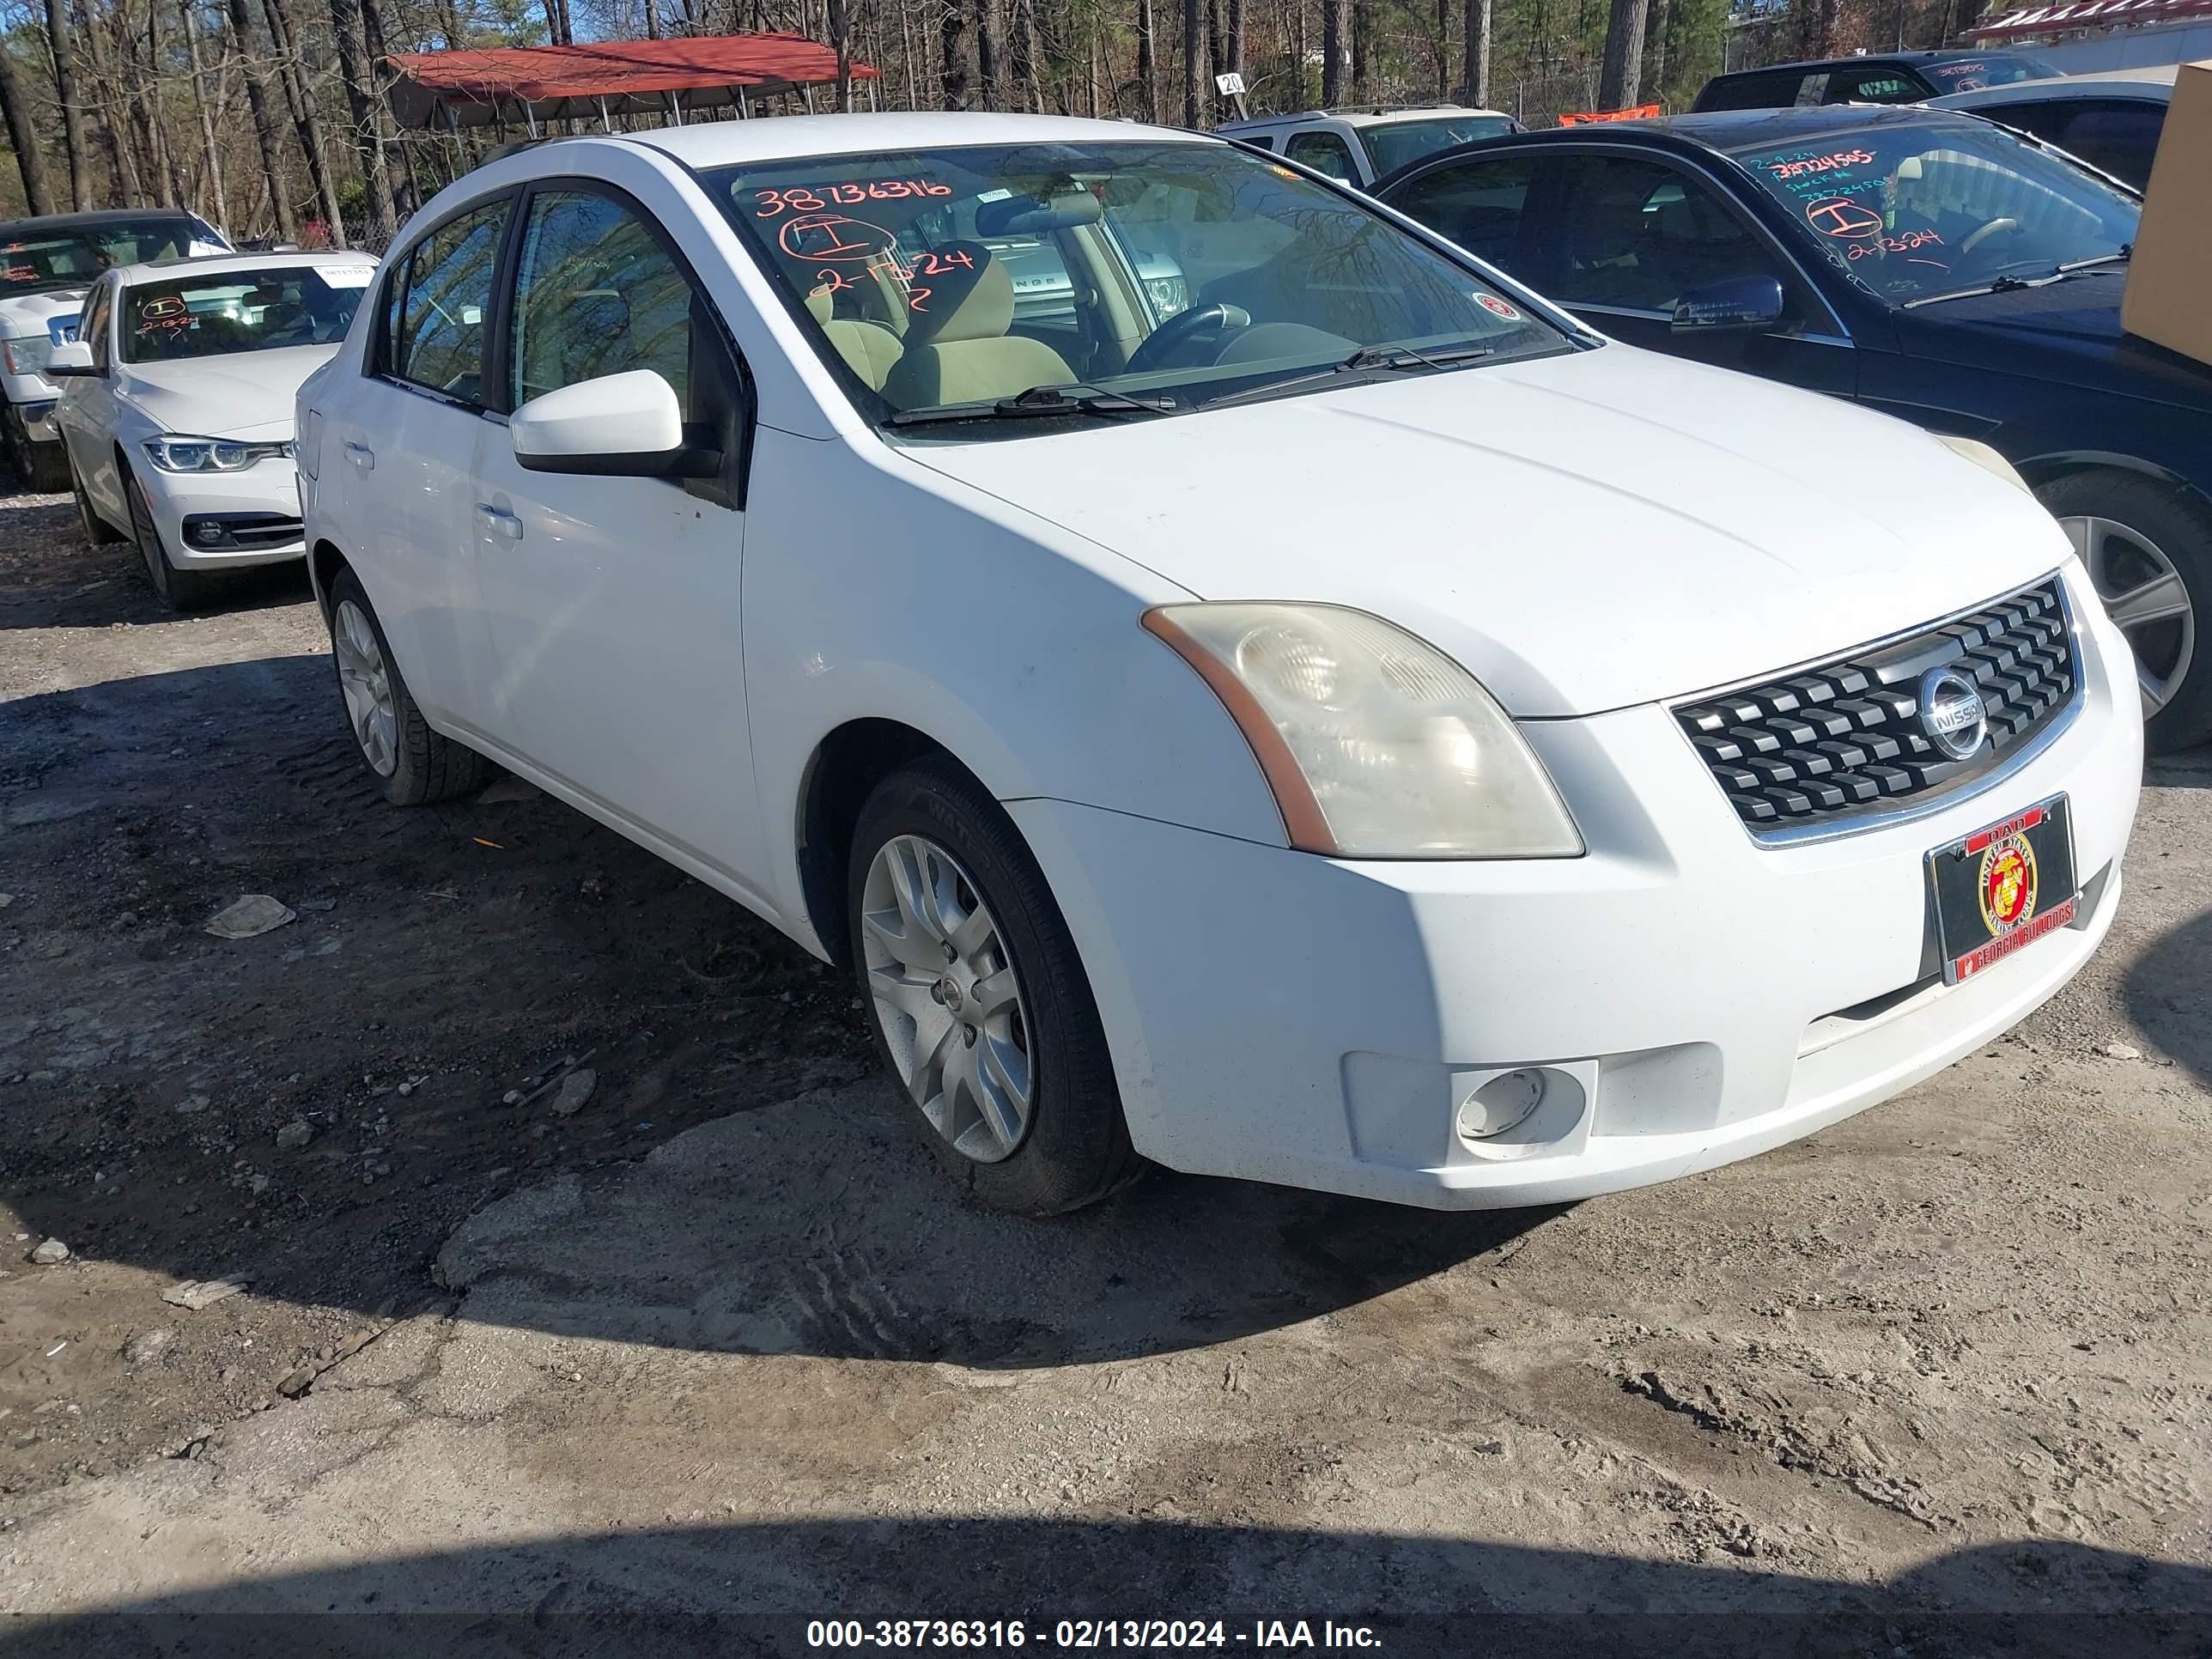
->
2037, 469, 2212, 754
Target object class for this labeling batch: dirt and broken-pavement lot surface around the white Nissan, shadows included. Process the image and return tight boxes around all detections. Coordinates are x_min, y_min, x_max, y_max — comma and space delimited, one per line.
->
0, 498, 2212, 1656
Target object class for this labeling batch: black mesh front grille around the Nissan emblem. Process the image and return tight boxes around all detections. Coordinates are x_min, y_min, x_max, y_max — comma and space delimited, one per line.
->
1674, 577, 2081, 830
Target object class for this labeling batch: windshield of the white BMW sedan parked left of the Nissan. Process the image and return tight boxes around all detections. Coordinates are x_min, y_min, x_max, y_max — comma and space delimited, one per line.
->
122, 261, 374, 362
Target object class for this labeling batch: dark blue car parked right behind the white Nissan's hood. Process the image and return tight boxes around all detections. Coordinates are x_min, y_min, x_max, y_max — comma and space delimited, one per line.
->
1374, 106, 2212, 750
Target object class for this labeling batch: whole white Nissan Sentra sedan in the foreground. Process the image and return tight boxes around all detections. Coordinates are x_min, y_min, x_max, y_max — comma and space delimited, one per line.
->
301, 115, 2143, 1212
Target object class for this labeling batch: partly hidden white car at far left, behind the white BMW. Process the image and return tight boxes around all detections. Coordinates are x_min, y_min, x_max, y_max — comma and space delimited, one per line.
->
0, 208, 230, 489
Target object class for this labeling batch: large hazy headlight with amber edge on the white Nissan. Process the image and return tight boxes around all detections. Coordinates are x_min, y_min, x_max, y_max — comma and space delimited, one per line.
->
1144, 604, 1582, 858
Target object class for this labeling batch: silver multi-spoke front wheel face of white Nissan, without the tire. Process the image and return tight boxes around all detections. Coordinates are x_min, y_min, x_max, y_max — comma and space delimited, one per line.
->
860, 836, 1036, 1164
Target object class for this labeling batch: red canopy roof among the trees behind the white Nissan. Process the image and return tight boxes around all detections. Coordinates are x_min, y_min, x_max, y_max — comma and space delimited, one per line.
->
387, 35, 878, 126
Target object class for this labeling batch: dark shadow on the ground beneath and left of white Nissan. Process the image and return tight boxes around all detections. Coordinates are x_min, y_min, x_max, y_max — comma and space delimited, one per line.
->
0, 654, 1544, 1367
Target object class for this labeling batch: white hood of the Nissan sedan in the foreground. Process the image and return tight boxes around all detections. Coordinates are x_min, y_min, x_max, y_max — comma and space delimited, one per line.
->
907, 345, 2069, 717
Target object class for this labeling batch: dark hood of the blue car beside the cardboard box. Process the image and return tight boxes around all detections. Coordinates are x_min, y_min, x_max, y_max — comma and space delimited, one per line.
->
1898, 265, 2212, 411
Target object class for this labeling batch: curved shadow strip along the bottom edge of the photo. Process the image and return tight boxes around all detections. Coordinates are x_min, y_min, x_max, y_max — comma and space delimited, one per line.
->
0, 1520, 2212, 1659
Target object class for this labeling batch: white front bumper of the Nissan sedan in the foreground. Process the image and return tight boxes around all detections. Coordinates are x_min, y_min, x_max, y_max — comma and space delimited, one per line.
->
1009, 577, 2142, 1207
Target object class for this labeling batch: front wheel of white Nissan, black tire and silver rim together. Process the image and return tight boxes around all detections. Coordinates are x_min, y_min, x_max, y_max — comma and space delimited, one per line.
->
845, 759, 1144, 1217
